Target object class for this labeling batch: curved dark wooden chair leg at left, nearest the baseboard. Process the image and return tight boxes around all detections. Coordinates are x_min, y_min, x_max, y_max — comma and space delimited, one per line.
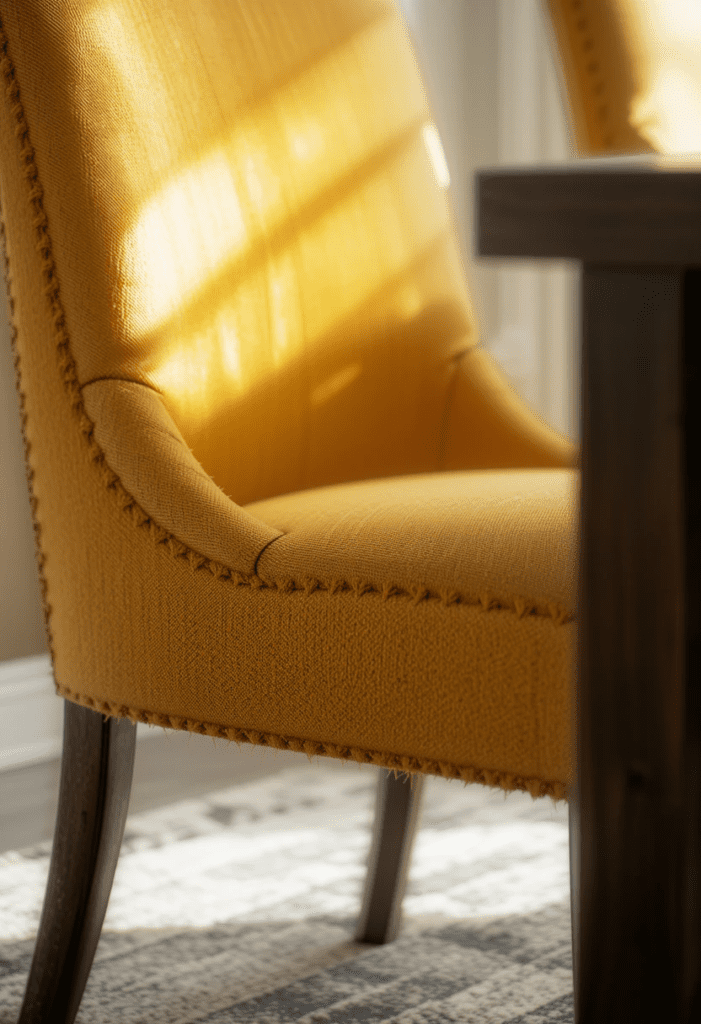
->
19, 701, 136, 1024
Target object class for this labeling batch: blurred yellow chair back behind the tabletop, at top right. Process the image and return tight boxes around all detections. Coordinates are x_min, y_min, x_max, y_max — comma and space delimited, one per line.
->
545, 0, 701, 155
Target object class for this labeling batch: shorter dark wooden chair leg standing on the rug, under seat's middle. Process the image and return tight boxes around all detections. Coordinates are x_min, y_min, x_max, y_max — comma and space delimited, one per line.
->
355, 769, 424, 945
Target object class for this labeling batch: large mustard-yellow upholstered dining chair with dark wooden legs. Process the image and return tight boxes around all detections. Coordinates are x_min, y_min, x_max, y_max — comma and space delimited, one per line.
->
0, 0, 687, 1024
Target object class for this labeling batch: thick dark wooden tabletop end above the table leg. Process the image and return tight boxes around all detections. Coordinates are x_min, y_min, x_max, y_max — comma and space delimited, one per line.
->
475, 158, 701, 266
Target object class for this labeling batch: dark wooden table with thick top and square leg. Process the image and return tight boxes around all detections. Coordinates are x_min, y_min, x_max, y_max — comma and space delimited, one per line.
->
475, 157, 701, 1024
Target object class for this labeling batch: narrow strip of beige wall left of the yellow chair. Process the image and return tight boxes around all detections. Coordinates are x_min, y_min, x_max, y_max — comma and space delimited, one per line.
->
0, 286, 47, 662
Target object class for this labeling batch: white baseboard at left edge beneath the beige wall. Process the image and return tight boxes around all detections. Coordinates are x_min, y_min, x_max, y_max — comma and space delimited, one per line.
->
0, 654, 154, 771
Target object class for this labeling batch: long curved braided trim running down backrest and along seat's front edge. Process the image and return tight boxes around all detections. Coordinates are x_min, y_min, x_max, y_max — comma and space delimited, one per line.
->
0, 19, 573, 625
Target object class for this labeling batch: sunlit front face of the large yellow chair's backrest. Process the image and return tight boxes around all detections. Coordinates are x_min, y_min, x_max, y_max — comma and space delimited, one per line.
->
3, 0, 491, 504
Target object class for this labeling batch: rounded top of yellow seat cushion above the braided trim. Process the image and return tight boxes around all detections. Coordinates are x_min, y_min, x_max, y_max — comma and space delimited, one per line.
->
246, 469, 577, 618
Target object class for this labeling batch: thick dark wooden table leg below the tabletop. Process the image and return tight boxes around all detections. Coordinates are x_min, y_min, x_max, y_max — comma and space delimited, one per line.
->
572, 264, 701, 1024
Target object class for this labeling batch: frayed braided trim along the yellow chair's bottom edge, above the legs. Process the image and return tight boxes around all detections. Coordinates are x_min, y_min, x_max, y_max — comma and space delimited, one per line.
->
56, 683, 569, 801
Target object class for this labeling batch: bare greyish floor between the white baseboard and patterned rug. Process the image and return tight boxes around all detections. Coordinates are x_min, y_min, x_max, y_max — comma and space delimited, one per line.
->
0, 730, 311, 853
